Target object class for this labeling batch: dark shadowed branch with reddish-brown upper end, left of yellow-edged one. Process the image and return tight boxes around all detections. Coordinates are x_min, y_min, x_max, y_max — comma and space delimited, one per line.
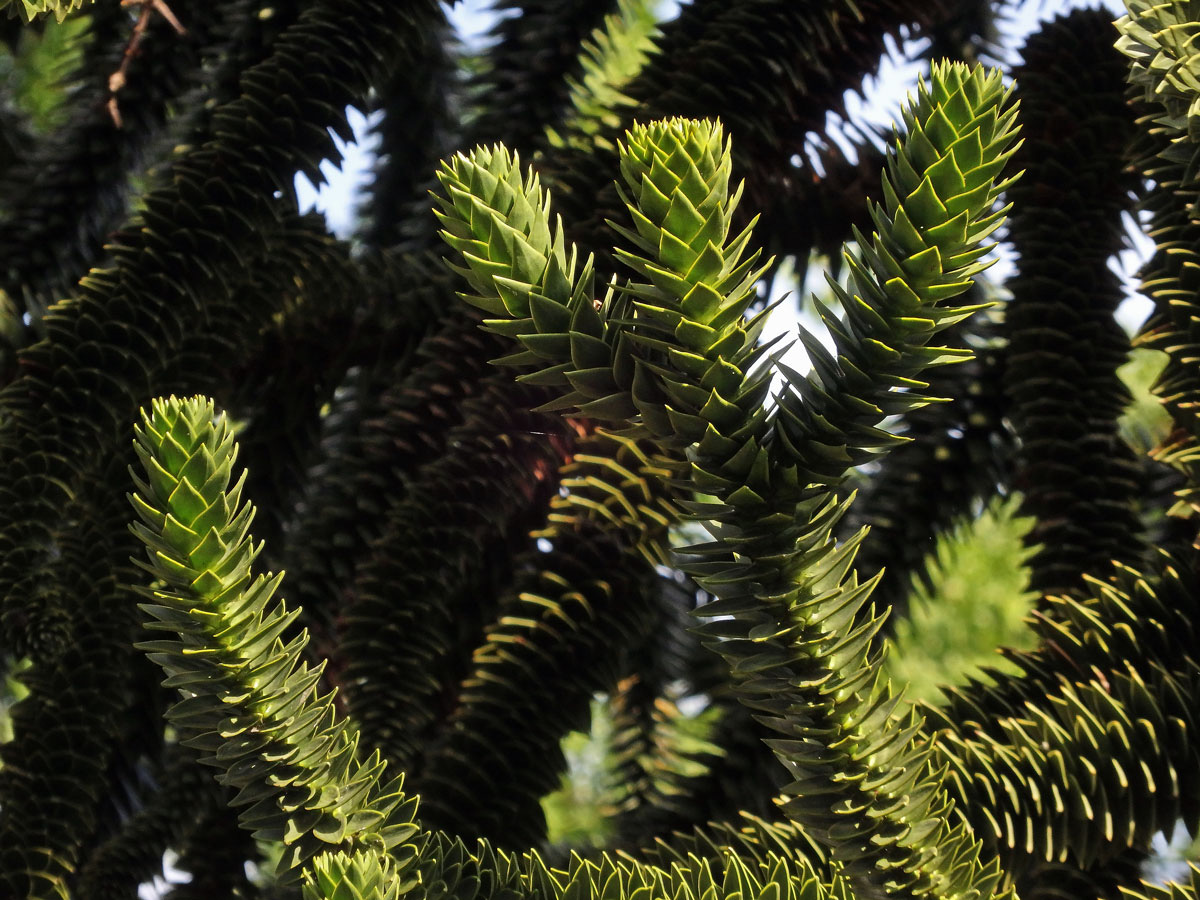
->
340, 373, 576, 770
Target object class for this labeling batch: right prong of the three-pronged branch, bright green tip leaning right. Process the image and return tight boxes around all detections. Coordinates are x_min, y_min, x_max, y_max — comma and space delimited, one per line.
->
779, 66, 1015, 482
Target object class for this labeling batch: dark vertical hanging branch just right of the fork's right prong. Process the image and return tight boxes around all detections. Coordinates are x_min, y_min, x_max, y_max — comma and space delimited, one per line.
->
1004, 11, 1140, 593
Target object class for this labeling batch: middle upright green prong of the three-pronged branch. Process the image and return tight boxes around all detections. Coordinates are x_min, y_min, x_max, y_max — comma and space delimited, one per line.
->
613, 119, 767, 451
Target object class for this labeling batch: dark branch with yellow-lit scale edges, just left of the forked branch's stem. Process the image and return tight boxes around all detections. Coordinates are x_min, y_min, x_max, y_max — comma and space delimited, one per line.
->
418, 522, 656, 847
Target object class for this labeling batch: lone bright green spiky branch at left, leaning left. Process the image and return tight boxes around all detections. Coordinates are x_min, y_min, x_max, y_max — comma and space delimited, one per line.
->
131, 397, 418, 877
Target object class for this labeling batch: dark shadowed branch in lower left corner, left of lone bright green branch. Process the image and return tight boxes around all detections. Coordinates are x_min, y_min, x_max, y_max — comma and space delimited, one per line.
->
0, 466, 140, 896
